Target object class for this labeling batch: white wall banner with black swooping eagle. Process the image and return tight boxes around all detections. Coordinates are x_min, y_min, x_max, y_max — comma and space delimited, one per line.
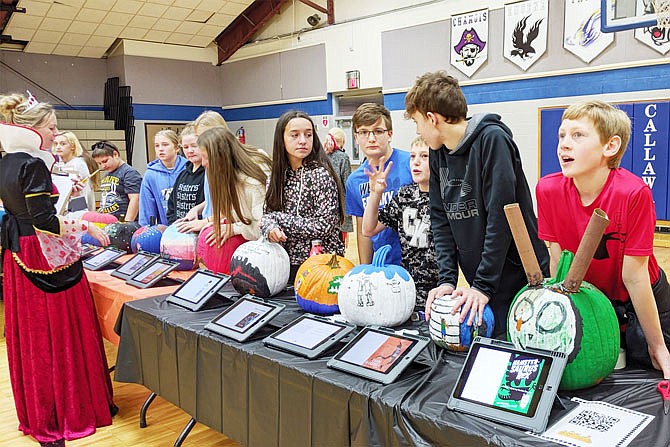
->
503, 0, 549, 71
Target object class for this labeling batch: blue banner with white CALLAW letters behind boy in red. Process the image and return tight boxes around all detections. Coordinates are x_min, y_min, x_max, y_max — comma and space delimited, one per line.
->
539, 100, 670, 220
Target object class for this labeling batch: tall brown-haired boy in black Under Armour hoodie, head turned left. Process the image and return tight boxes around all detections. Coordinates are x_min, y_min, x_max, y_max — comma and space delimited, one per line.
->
405, 71, 549, 337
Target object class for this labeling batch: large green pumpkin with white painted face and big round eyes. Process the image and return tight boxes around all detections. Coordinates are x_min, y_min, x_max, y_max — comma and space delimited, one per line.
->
507, 251, 620, 390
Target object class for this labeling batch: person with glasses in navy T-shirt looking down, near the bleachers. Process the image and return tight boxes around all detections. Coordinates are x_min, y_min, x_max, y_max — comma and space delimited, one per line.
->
91, 141, 142, 222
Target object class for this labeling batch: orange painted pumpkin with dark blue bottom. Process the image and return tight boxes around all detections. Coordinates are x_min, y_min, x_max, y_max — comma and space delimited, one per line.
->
295, 254, 354, 315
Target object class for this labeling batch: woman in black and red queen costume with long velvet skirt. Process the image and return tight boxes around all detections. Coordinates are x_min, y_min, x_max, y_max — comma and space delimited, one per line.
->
0, 94, 118, 446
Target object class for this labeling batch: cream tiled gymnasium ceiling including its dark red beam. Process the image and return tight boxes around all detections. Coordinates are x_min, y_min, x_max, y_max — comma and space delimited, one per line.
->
0, 0, 334, 64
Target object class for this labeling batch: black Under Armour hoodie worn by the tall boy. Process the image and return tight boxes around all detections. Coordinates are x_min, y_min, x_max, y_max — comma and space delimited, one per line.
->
430, 114, 549, 334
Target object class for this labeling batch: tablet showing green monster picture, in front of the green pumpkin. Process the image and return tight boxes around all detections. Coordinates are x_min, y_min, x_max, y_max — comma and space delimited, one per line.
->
447, 337, 567, 433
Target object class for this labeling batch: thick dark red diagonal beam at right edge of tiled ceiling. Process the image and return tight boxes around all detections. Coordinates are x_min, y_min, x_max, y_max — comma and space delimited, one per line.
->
214, 0, 290, 65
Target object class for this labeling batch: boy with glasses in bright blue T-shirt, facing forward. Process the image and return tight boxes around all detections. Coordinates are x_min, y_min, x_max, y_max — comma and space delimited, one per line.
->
345, 103, 413, 265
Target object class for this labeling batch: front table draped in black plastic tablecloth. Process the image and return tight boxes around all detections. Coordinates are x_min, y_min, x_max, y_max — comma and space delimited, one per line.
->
115, 297, 670, 447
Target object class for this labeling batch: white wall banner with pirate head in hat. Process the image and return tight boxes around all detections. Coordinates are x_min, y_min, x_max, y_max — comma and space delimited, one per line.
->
450, 9, 489, 77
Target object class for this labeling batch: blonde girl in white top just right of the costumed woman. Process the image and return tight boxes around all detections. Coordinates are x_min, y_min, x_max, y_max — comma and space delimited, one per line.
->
53, 132, 97, 211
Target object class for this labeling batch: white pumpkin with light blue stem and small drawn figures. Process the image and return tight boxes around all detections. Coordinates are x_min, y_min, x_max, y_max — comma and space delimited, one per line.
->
338, 245, 416, 326
